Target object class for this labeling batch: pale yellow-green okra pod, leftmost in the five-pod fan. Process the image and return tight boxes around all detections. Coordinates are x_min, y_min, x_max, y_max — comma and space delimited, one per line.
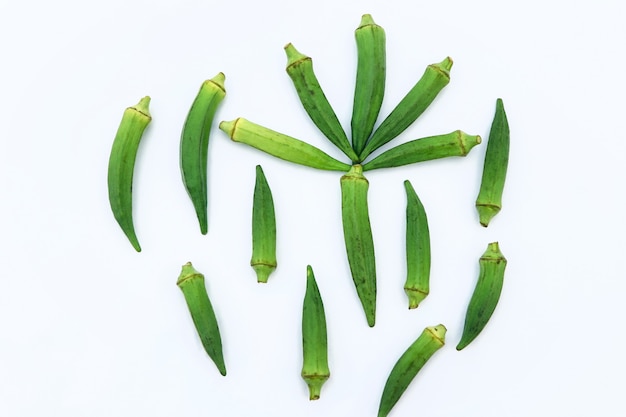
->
220, 117, 350, 172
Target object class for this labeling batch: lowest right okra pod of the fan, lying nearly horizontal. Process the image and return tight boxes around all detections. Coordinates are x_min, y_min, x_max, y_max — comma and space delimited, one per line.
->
363, 130, 481, 171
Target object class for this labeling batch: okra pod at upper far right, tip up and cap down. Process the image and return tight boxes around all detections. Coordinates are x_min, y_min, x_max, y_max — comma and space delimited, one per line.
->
476, 98, 510, 227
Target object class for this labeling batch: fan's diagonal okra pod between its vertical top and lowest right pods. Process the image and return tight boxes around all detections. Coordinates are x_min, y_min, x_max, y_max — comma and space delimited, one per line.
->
359, 57, 452, 161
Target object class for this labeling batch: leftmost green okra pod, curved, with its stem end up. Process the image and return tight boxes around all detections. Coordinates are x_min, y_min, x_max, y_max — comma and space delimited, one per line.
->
108, 97, 152, 252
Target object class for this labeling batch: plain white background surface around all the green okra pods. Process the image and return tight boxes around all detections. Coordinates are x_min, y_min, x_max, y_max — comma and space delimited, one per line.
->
0, 0, 626, 417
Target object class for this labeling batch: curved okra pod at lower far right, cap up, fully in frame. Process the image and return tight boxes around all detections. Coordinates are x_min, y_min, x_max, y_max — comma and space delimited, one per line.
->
456, 242, 506, 350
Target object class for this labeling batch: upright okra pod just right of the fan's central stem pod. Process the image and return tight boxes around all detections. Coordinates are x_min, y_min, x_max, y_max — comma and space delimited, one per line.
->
404, 180, 430, 309
